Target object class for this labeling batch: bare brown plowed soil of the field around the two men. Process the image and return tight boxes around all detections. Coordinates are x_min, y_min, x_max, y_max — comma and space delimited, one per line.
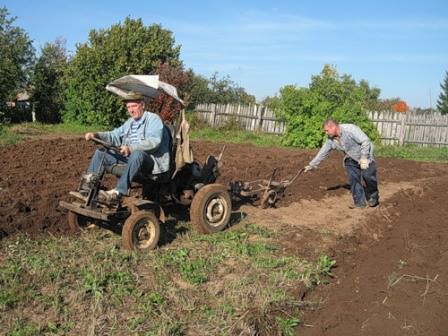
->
0, 137, 448, 335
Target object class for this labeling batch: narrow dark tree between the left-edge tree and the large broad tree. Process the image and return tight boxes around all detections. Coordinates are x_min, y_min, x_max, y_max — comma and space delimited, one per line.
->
31, 39, 67, 123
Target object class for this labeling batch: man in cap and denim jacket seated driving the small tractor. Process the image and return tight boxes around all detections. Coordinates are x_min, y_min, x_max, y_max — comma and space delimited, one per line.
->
84, 92, 170, 203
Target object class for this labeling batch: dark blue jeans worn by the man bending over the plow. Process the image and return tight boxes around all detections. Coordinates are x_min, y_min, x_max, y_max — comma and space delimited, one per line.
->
344, 158, 379, 205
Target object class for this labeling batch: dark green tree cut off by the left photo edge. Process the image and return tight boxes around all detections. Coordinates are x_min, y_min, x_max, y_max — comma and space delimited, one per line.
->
0, 7, 34, 108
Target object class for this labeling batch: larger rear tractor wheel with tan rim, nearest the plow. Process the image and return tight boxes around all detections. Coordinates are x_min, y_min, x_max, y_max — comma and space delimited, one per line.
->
190, 183, 232, 233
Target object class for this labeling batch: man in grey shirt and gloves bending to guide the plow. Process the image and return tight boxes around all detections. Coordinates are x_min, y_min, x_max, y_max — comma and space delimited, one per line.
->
305, 119, 379, 209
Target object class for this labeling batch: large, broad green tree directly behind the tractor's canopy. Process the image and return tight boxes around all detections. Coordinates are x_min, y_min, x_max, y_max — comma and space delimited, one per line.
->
63, 17, 181, 126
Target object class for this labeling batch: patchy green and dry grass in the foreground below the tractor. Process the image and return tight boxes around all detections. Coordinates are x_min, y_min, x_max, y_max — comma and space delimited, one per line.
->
0, 223, 334, 335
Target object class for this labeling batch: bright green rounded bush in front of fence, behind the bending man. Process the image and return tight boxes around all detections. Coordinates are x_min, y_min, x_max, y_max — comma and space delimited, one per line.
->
274, 65, 378, 148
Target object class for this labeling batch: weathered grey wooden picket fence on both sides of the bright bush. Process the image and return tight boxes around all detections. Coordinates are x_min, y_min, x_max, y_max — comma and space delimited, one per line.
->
195, 104, 448, 146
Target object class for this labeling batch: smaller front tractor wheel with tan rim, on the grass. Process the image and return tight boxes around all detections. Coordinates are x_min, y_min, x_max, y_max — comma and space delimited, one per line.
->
121, 210, 160, 251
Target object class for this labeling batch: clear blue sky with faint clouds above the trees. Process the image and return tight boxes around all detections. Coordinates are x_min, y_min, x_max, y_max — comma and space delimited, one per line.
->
0, 0, 448, 107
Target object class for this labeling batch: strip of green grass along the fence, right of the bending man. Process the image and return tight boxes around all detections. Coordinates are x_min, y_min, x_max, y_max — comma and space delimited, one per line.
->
375, 145, 448, 162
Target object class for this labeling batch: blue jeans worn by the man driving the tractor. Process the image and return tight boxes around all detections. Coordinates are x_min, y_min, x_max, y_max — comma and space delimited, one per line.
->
87, 149, 154, 195
